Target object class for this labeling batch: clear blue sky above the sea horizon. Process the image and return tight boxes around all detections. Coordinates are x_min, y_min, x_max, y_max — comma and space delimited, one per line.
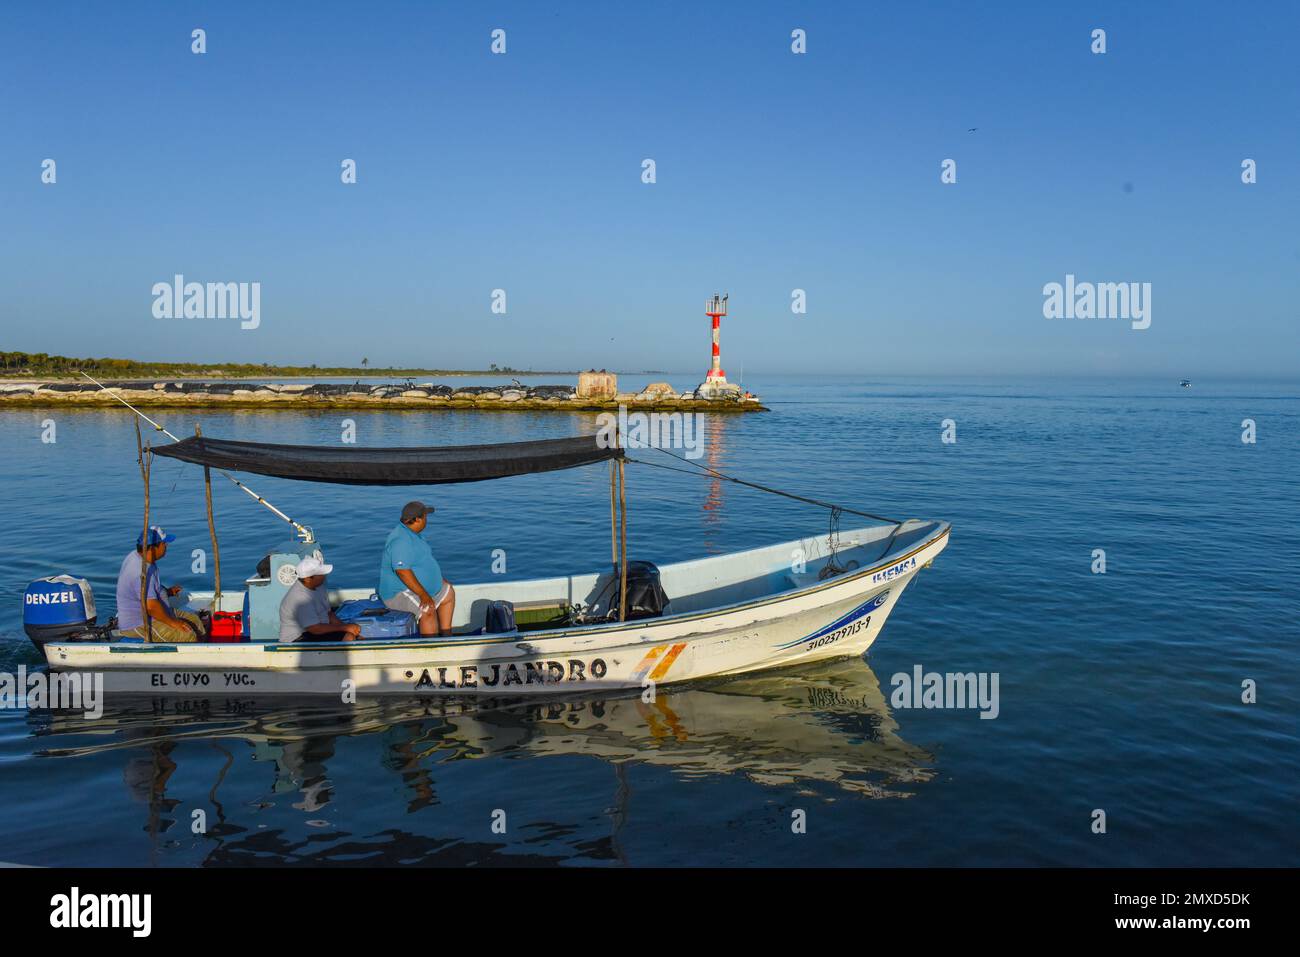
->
0, 1, 1300, 377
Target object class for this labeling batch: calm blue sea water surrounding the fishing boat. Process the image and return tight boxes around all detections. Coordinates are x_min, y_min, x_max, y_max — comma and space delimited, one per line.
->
0, 376, 1300, 866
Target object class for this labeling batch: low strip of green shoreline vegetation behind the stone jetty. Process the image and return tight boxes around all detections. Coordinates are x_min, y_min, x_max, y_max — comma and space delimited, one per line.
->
0, 352, 577, 382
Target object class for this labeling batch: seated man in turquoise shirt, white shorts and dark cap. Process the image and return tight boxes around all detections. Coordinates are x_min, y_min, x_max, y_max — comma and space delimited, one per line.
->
380, 502, 456, 635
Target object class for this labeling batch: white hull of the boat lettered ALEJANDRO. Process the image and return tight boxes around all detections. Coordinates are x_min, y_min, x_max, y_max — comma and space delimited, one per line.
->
46, 523, 949, 700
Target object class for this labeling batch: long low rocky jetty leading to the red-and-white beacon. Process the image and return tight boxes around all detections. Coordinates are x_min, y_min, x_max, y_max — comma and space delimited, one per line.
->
0, 381, 767, 412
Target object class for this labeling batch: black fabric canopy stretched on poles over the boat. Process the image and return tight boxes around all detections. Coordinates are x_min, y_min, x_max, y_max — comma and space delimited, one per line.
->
152, 436, 623, 485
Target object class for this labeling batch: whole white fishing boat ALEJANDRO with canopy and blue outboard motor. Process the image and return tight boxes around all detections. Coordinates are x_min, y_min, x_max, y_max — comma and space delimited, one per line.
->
23, 390, 949, 696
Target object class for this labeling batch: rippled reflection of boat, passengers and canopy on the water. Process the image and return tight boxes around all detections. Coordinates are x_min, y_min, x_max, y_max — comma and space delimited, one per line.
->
29, 658, 933, 863
